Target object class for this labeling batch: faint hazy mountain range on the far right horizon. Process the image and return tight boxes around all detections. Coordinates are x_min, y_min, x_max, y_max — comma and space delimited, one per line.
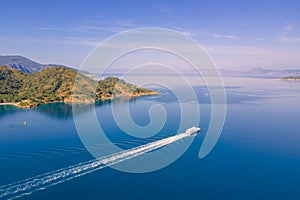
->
220, 68, 300, 78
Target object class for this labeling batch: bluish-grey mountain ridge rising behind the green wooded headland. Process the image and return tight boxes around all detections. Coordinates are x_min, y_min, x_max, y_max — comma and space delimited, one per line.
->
0, 56, 69, 74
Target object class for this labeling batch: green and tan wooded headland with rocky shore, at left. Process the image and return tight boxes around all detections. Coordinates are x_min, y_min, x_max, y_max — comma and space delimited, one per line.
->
0, 66, 158, 108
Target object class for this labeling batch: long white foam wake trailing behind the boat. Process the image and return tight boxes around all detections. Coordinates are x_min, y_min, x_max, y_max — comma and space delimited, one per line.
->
0, 133, 190, 199
